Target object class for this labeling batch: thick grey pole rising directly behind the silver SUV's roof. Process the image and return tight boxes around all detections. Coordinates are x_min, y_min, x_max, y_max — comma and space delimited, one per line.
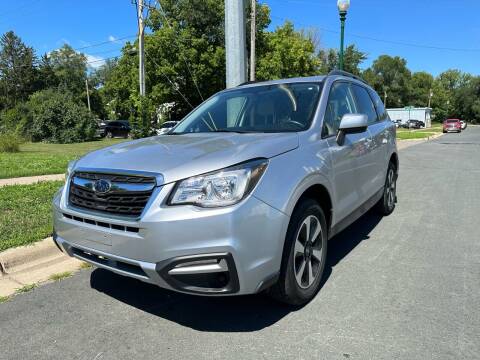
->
225, 0, 247, 88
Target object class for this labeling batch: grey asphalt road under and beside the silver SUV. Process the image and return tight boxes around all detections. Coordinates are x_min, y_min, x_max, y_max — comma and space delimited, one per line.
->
0, 127, 480, 360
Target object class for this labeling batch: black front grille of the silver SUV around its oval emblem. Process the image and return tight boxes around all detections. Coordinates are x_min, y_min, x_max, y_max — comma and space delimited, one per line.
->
69, 172, 156, 217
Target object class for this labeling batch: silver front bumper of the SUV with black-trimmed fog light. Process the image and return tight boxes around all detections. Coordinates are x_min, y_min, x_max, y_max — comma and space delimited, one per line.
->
53, 184, 289, 295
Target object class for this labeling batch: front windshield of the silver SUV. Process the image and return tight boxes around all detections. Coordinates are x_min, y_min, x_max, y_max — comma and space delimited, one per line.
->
172, 83, 323, 134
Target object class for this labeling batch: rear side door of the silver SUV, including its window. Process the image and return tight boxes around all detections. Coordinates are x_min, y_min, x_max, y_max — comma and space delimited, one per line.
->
352, 84, 387, 202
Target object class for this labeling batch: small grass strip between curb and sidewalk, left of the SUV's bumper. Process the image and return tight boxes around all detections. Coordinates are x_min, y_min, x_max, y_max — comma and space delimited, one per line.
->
0, 181, 63, 251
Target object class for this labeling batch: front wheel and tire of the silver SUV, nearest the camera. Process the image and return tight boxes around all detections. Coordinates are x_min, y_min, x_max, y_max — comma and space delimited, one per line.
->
270, 199, 328, 306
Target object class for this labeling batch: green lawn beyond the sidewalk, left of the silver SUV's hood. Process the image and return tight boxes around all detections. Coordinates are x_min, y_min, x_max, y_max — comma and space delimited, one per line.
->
0, 139, 125, 179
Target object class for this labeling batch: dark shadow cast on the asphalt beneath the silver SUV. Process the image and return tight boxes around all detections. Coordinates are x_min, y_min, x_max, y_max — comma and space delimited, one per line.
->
90, 213, 381, 332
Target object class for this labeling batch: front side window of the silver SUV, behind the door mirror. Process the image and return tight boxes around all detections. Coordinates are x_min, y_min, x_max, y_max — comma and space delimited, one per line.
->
322, 82, 357, 136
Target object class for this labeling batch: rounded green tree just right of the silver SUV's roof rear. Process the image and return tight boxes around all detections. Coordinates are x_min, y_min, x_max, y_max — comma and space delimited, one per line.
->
363, 55, 411, 107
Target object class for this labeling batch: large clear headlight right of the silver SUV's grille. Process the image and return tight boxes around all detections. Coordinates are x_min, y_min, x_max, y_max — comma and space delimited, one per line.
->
168, 159, 268, 207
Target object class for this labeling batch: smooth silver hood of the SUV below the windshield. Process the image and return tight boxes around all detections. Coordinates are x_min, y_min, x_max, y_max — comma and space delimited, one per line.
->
75, 133, 298, 185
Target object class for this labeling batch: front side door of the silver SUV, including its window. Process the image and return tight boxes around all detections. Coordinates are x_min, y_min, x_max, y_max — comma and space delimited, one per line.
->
322, 81, 370, 224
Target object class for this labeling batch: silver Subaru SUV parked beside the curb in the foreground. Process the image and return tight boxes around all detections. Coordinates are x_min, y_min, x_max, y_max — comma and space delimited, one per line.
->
53, 71, 398, 304
